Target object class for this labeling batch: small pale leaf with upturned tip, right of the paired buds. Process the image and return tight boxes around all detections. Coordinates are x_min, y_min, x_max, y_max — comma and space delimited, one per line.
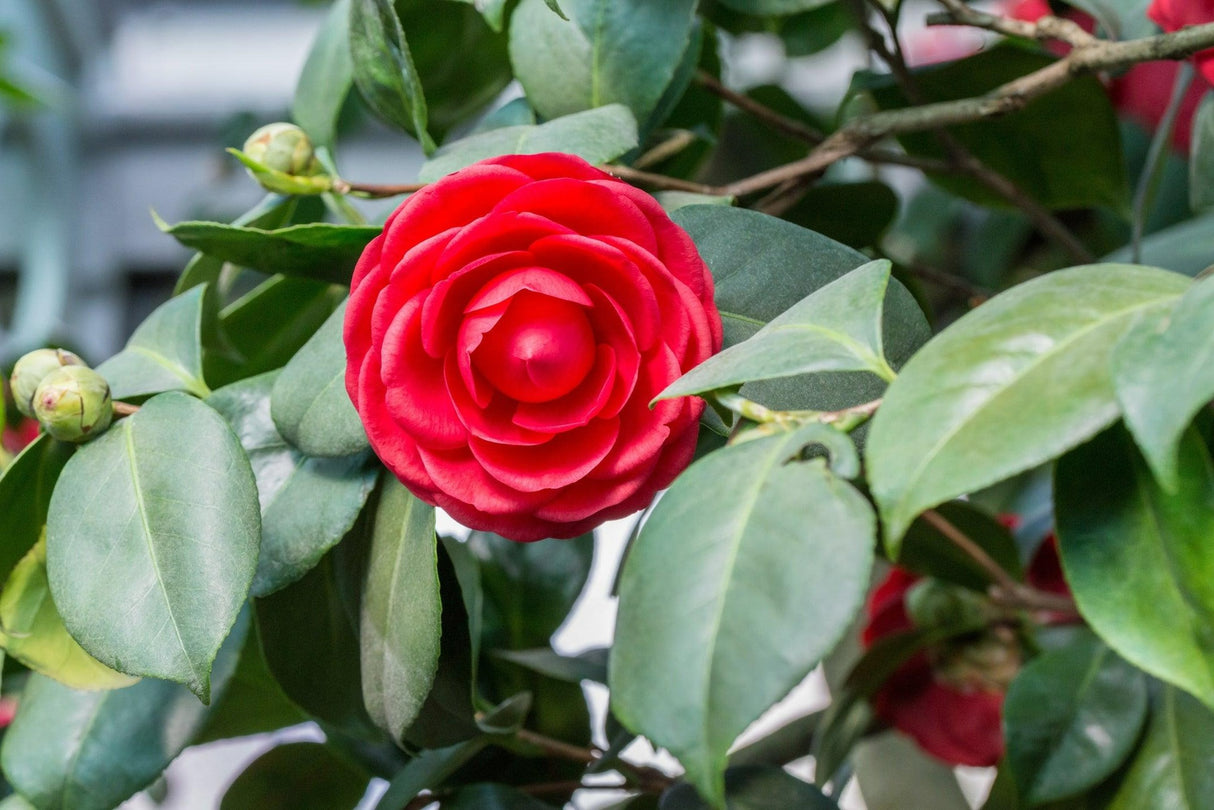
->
97, 285, 210, 400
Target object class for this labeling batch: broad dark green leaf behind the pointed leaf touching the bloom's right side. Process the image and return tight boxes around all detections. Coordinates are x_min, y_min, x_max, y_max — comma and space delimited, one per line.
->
671, 205, 931, 410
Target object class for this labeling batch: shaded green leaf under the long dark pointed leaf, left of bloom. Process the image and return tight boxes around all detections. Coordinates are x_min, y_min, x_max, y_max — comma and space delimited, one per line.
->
205, 276, 346, 386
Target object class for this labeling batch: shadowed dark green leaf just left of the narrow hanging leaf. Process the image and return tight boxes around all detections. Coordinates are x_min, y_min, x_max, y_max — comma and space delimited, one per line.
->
254, 548, 381, 738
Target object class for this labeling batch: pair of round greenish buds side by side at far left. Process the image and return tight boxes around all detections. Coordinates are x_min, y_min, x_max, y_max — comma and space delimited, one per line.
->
8, 349, 114, 443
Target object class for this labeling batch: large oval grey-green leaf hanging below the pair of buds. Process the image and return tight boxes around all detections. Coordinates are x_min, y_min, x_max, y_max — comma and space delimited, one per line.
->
46, 392, 261, 703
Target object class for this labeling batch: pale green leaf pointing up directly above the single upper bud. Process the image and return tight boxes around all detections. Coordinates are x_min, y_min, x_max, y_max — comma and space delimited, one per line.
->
291, 0, 354, 147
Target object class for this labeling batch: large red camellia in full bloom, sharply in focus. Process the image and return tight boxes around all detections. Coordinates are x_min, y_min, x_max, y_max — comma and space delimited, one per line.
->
345, 154, 721, 540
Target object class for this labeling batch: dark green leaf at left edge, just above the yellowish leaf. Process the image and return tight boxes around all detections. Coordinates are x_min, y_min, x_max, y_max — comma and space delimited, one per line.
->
0, 434, 75, 590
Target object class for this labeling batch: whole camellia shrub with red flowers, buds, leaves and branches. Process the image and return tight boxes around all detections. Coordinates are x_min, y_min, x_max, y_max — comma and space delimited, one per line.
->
0, 0, 1214, 810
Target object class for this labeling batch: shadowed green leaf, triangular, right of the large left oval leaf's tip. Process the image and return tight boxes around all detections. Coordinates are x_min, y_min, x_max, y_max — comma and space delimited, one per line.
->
194, 622, 308, 744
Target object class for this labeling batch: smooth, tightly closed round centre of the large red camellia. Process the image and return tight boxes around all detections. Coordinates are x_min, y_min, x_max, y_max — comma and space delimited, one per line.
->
472, 291, 595, 402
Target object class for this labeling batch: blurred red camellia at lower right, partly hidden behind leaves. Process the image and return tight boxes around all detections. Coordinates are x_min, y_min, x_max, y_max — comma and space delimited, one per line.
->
861, 536, 1070, 766
